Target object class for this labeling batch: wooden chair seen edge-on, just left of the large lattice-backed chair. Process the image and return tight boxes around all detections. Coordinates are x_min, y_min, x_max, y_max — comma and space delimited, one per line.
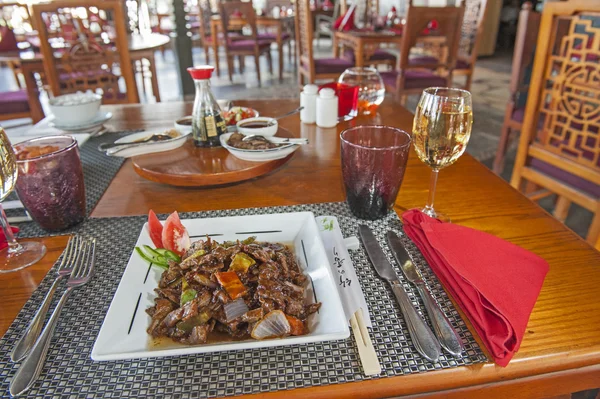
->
493, 1, 541, 175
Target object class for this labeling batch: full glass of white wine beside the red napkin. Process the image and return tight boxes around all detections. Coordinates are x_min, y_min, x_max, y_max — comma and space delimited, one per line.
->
413, 87, 473, 221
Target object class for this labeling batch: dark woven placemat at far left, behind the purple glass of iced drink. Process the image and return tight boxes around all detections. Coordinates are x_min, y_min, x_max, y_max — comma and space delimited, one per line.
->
6, 130, 141, 237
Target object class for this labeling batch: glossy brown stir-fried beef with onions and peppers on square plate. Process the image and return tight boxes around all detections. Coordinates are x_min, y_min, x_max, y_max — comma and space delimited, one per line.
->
146, 237, 321, 345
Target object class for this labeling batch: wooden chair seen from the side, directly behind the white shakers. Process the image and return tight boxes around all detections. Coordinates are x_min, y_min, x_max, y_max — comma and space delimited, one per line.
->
296, 0, 354, 86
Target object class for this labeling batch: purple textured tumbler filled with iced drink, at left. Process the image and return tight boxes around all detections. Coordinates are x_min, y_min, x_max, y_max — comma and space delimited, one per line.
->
15, 136, 86, 231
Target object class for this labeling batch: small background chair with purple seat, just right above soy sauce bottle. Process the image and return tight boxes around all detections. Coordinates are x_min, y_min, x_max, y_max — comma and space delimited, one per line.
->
219, 1, 273, 86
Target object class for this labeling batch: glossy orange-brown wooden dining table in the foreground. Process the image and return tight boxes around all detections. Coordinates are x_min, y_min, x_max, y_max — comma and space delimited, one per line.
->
0, 99, 600, 399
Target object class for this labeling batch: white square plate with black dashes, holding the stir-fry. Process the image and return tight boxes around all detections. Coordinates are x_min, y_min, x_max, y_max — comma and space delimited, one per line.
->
92, 212, 350, 361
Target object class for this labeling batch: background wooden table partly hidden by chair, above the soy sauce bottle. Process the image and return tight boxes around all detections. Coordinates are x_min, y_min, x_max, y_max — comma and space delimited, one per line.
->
210, 15, 294, 77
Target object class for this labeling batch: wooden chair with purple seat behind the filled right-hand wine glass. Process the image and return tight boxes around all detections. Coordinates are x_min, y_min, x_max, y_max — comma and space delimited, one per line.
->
381, 3, 464, 103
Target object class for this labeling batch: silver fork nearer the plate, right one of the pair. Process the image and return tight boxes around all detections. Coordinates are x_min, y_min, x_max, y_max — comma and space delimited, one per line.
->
9, 238, 96, 396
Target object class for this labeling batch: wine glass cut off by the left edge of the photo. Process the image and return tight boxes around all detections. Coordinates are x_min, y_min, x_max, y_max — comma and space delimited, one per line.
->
0, 128, 46, 273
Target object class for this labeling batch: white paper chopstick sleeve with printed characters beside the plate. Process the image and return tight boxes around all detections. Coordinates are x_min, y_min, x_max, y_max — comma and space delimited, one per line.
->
315, 216, 371, 327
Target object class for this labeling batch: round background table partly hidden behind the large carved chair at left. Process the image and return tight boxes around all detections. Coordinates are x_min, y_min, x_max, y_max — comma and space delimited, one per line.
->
0, 33, 171, 123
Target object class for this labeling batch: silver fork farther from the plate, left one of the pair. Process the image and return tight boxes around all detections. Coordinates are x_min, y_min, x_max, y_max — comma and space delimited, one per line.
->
10, 236, 81, 362
